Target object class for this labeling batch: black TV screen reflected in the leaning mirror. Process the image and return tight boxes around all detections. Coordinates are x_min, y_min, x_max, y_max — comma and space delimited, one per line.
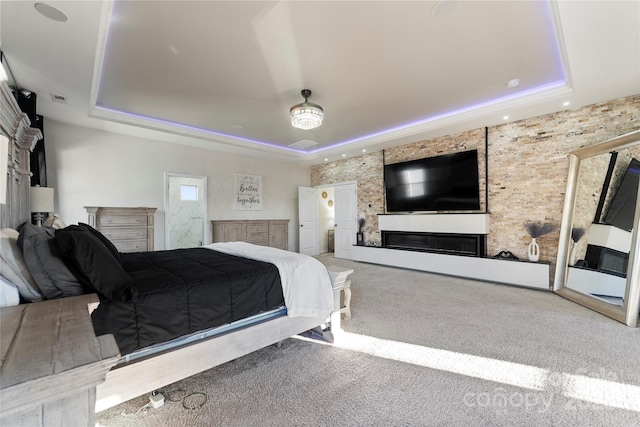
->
604, 159, 640, 231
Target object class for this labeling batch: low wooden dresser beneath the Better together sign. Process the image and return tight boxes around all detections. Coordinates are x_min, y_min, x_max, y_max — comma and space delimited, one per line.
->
211, 219, 289, 250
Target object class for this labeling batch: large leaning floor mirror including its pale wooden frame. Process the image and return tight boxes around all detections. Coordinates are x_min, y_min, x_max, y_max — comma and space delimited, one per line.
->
553, 130, 640, 327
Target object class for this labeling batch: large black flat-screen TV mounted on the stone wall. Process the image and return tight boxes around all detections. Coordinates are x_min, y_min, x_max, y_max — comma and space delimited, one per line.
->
384, 150, 480, 212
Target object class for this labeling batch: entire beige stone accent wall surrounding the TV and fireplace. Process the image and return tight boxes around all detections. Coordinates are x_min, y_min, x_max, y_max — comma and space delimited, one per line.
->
311, 95, 640, 277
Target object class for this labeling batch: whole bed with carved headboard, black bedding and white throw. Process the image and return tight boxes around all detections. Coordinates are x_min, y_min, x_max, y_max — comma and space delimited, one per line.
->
0, 78, 350, 420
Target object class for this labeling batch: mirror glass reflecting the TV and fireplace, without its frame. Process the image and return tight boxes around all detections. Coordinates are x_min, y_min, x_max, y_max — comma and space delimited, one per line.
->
566, 146, 640, 307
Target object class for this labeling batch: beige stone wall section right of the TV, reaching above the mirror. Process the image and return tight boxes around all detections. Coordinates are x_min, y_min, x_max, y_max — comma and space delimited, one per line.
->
487, 96, 640, 277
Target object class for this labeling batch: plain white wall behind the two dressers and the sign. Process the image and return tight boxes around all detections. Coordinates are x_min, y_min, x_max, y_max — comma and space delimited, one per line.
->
44, 120, 310, 251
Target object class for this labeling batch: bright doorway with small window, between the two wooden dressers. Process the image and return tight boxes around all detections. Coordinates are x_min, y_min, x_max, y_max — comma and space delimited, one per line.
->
165, 173, 207, 249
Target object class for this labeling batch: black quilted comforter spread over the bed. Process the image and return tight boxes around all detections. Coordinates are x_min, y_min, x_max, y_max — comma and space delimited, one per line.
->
91, 248, 284, 355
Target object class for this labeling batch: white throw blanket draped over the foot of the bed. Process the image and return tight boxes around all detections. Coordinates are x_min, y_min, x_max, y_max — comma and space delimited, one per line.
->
204, 242, 333, 317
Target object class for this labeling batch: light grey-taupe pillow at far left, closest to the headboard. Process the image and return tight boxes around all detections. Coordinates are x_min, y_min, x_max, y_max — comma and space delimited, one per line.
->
0, 228, 42, 302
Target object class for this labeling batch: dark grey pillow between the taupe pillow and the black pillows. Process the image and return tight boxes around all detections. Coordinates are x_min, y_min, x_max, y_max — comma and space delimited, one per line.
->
18, 223, 87, 299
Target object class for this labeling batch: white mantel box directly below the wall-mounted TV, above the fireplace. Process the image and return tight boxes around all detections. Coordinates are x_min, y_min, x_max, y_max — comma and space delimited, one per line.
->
378, 213, 489, 234
